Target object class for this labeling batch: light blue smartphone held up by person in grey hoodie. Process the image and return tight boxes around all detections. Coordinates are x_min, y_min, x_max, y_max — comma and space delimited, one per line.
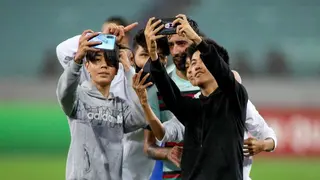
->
89, 34, 116, 50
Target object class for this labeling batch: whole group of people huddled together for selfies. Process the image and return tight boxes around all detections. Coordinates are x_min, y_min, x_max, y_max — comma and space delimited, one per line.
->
57, 14, 277, 180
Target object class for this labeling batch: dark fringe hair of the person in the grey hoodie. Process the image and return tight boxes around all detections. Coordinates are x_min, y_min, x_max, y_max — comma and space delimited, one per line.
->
86, 45, 119, 69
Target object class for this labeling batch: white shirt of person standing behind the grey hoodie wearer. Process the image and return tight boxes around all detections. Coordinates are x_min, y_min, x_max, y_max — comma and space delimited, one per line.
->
56, 35, 155, 180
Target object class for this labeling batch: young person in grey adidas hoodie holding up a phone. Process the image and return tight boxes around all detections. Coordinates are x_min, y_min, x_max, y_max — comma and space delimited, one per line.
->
57, 30, 146, 180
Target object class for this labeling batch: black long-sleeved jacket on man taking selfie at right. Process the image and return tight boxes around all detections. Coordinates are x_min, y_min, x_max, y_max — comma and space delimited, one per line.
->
151, 41, 248, 180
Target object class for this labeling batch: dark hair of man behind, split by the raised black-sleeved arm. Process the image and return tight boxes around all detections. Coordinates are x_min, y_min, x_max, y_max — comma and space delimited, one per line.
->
133, 29, 170, 56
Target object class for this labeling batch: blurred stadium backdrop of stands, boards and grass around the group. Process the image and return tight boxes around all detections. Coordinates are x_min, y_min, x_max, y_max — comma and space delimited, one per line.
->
0, 0, 320, 180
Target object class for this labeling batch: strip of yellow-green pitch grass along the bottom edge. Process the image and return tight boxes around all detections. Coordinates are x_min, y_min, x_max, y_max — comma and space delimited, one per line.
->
0, 155, 320, 180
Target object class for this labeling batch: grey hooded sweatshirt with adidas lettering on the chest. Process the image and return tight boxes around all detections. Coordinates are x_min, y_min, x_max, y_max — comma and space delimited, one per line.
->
57, 61, 146, 180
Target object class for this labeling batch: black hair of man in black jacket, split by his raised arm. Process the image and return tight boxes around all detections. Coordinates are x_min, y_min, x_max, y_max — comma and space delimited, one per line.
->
187, 38, 229, 65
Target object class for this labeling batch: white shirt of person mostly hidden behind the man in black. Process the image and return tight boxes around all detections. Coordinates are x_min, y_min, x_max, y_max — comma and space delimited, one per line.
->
156, 92, 277, 180
